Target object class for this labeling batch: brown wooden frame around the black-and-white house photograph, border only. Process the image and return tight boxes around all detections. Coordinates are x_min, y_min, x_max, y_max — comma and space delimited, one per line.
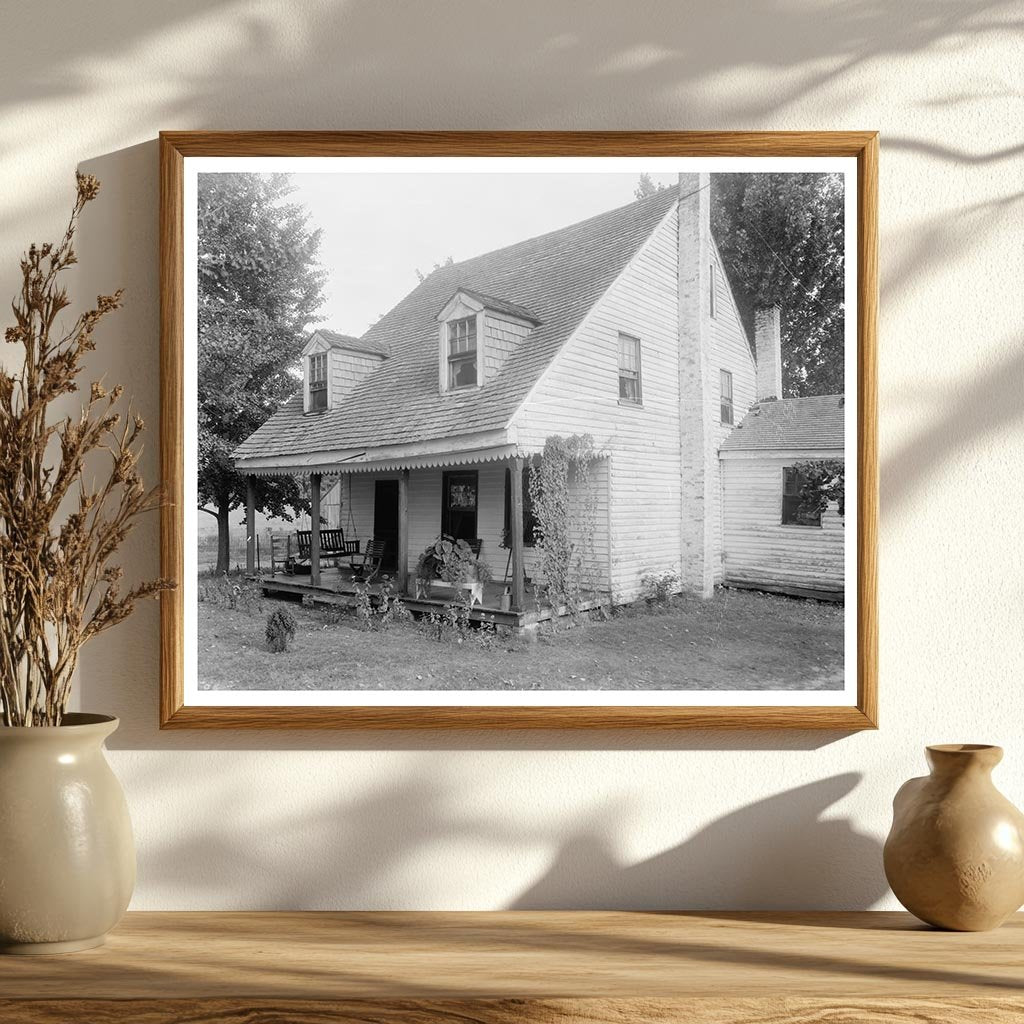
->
160, 131, 879, 730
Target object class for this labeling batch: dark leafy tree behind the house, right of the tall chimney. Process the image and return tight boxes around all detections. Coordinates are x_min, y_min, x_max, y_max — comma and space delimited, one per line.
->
711, 173, 846, 397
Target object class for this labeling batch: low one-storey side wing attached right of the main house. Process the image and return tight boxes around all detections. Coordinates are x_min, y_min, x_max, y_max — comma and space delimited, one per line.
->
719, 394, 852, 601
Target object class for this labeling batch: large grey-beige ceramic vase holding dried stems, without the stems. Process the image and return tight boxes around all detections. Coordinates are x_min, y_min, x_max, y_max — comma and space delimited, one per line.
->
0, 714, 135, 953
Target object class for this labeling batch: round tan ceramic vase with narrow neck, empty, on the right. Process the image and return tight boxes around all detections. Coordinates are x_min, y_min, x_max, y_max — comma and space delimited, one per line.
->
885, 743, 1024, 932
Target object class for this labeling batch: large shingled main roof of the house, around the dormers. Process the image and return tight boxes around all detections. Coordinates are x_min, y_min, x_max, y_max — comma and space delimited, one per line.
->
234, 188, 676, 459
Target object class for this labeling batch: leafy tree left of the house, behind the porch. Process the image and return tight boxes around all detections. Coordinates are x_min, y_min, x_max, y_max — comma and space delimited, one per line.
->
198, 173, 326, 572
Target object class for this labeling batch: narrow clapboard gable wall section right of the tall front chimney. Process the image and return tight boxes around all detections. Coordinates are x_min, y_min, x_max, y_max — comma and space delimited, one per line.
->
710, 237, 758, 583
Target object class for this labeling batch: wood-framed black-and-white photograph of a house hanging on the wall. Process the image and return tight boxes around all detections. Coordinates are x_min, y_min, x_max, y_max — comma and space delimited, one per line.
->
161, 132, 878, 730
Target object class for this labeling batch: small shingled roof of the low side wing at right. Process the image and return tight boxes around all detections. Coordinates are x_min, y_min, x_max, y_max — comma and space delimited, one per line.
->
720, 394, 845, 452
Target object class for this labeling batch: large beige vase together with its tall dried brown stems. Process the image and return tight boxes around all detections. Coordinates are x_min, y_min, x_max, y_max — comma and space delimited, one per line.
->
0, 174, 170, 952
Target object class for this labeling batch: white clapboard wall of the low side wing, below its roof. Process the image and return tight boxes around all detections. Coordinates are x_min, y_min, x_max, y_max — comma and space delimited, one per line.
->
721, 452, 846, 591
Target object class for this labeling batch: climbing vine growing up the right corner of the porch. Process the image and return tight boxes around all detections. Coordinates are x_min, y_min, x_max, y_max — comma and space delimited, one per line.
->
528, 434, 599, 609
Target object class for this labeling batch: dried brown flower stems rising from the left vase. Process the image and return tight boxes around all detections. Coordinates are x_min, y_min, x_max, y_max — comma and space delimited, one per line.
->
0, 173, 172, 726
